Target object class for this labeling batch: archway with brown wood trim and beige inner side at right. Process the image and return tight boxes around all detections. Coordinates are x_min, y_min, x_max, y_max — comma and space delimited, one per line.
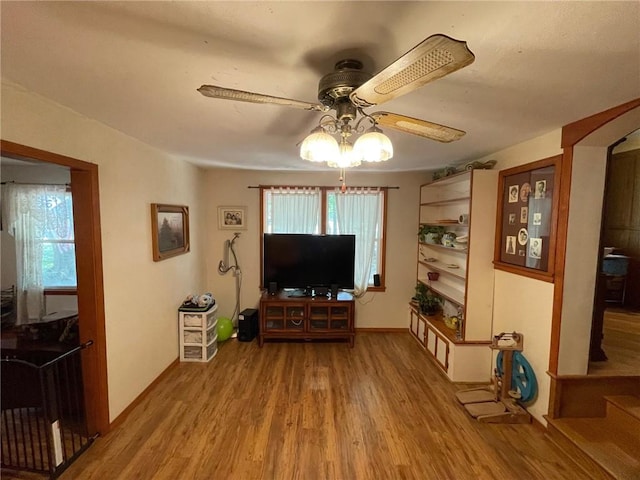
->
549, 99, 640, 418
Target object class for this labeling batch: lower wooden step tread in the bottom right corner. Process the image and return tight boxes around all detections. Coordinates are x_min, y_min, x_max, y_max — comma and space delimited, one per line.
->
547, 417, 640, 480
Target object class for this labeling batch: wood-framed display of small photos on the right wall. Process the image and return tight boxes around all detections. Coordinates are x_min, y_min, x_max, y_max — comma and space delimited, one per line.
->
493, 155, 562, 282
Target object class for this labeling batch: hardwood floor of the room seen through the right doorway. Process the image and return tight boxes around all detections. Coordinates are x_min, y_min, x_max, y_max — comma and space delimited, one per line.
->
589, 308, 640, 375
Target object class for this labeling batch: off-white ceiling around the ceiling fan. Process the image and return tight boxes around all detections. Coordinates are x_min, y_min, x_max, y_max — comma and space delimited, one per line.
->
0, 1, 640, 171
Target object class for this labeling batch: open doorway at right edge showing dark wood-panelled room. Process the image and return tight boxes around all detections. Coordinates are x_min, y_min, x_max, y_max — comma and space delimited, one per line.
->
588, 130, 640, 375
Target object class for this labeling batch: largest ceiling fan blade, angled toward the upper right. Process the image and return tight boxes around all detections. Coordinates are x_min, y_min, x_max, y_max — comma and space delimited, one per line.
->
349, 34, 476, 108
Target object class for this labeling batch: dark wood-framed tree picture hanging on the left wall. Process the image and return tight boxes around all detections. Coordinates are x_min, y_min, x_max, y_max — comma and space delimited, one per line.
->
151, 203, 190, 262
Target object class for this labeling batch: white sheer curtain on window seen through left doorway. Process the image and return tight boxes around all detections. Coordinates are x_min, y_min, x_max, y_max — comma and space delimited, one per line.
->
2, 183, 73, 325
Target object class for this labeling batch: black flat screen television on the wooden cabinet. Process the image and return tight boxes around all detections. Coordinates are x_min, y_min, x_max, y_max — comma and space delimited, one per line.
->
262, 233, 356, 290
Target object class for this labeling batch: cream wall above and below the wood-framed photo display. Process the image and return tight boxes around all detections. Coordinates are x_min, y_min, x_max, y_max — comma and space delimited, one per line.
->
481, 129, 562, 424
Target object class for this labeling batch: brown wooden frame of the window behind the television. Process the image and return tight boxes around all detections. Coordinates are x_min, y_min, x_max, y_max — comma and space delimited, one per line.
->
259, 185, 389, 292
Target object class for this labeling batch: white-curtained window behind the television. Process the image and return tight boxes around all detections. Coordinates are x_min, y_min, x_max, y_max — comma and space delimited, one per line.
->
262, 187, 386, 294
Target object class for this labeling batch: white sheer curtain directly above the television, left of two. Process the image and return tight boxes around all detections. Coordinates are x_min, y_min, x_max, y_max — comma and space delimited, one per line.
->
264, 187, 322, 233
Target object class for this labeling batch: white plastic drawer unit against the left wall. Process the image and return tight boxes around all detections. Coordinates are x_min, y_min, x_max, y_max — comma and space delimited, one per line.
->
179, 305, 218, 362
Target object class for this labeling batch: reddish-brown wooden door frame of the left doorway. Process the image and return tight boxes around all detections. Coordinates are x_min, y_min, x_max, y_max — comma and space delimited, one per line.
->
0, 140, 109, 435
